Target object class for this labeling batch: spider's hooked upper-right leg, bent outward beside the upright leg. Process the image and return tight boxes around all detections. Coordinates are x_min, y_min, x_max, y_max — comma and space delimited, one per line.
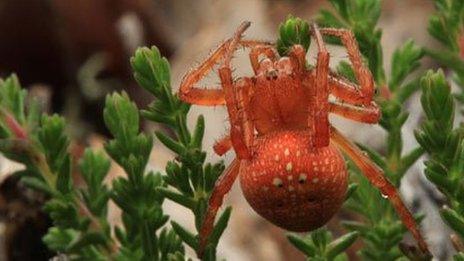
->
320, 28, 374, 105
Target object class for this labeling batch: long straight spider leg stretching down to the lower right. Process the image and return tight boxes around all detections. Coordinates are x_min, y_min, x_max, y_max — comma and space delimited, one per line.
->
331, 127, 430, 254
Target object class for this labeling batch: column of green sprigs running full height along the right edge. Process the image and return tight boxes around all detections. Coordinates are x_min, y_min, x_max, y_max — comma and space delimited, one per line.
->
415, 0, 464, 260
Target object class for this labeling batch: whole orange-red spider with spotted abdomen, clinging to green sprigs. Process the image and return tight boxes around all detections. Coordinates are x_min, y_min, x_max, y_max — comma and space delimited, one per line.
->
179, 22, 429, 255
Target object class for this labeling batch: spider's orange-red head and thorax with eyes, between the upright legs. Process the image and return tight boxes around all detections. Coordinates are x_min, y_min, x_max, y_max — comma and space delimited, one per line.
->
249, 57, 314, 131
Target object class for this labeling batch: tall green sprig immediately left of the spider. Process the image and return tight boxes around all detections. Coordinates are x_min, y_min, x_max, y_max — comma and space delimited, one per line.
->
131, 47, 231, 260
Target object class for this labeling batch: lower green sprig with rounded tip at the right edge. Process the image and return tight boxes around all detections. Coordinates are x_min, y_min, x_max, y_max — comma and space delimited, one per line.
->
415, 71, 464, 259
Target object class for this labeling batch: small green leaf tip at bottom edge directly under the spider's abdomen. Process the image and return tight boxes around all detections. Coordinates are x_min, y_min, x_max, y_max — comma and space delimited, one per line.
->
287, 228, 358, 261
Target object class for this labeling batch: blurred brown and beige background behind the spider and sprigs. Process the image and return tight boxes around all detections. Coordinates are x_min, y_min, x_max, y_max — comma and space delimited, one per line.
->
0, 0, 452, 261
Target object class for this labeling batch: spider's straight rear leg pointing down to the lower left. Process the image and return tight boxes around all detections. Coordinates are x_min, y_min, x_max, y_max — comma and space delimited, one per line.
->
197, 159, 240, 257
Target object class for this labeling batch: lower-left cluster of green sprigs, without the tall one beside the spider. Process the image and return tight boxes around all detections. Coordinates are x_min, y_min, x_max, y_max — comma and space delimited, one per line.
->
0, 75, 184, 260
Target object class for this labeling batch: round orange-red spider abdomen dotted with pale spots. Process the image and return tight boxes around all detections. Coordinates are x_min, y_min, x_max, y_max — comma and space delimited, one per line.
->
240, 130, 348, 231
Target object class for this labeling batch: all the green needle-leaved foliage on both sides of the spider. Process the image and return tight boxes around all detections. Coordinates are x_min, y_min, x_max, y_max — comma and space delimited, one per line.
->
0, 3, 464, 260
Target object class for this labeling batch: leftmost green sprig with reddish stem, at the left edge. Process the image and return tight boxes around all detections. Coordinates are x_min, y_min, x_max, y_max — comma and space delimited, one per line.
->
0, 75, 116, 260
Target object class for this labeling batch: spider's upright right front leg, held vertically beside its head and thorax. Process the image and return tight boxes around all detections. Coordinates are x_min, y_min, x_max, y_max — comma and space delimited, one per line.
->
308, 24, 330, 148
